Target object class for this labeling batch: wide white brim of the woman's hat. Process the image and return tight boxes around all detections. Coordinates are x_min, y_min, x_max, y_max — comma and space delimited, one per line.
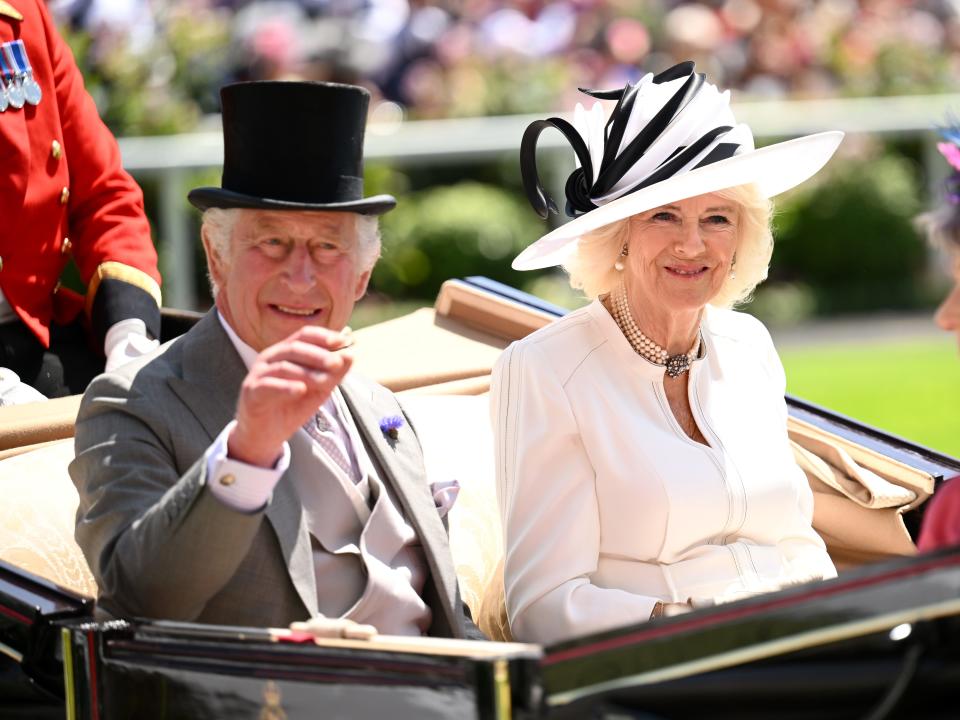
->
512, 130, 843, 270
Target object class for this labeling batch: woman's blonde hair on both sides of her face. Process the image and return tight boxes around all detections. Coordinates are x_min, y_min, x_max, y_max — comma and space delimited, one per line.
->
563, 185, 773, 307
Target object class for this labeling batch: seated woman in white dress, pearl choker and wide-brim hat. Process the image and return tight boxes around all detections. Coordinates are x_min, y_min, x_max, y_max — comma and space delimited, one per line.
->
491, 63, 842, 643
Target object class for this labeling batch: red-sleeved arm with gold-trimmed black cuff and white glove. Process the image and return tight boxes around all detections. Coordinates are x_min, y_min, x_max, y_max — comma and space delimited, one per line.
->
39, 3, 161, 370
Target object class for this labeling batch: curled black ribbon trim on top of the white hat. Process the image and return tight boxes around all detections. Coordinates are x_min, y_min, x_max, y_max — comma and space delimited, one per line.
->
520, 60, 739, 219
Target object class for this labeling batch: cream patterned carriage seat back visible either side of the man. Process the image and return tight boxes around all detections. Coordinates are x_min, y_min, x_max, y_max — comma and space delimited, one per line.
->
0, 395, 503, 636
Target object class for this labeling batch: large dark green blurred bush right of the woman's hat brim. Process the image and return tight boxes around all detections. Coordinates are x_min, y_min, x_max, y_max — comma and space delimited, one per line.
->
768, 154, 927, 314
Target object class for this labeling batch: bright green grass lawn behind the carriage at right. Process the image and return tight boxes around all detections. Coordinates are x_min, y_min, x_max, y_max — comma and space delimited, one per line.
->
780, 337, 960, 457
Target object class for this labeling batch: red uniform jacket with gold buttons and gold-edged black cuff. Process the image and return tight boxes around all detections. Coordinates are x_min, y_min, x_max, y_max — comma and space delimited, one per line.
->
0, 0, 160, 347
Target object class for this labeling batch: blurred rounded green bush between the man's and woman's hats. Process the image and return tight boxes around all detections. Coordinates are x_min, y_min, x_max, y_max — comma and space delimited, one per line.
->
372, 182, 545, 298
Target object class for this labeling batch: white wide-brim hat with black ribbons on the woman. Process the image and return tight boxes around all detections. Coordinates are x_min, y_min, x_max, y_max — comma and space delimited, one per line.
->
513, 62, 843, 270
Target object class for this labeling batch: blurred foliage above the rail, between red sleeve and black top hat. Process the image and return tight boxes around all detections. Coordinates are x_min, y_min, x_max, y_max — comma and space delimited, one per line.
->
62, 4, 230, 136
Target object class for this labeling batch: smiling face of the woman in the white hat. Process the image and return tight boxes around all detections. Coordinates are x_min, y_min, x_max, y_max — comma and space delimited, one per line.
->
625, 194, 740, 312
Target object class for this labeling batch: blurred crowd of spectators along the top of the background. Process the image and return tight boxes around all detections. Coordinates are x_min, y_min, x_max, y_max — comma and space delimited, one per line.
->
51, 0, 960, 132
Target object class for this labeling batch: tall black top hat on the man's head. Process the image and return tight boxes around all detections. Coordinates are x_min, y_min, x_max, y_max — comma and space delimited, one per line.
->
187, 81, 397, 215
